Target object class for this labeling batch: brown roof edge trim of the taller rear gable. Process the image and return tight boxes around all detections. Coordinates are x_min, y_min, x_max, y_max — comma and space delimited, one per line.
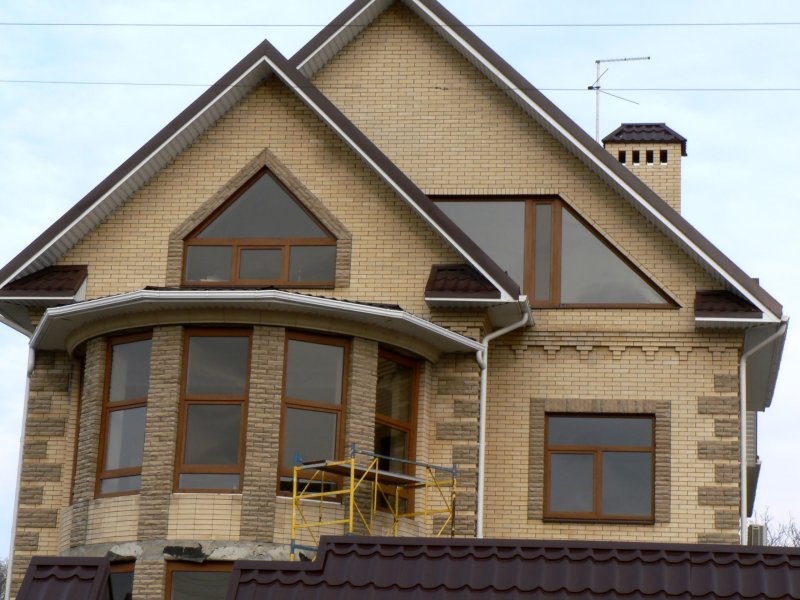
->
292, 0, 783, 317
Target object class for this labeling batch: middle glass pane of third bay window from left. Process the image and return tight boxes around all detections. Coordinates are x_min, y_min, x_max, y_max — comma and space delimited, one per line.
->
283, 408, 337, 469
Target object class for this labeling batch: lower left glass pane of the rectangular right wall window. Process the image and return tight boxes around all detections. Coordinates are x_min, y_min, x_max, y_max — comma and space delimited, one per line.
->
550, 453, 594, 513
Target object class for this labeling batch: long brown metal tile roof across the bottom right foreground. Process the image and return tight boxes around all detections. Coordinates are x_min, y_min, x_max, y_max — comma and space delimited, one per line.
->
227, 536, 800, 600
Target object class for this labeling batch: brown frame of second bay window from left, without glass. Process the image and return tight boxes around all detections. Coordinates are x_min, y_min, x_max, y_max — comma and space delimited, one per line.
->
173, 328, 253, 494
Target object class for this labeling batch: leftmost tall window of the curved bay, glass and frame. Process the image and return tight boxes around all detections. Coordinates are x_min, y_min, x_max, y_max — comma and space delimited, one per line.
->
97, 333, 151, 496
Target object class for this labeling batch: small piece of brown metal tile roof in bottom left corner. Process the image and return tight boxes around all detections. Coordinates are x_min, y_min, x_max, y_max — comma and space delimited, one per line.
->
16, 556, 111, 600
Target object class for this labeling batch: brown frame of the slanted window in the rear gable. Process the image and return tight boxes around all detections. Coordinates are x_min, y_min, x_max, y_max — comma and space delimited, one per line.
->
433, 196, 677, 309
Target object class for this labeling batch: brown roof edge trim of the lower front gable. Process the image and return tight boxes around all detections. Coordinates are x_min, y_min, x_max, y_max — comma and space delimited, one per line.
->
0, 35, 520, 300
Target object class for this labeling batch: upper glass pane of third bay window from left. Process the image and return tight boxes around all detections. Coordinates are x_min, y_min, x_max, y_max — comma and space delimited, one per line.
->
285, 340, 344, 404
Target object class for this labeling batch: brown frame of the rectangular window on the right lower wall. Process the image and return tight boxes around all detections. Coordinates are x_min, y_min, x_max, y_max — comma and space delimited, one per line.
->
543, 413, 656, 524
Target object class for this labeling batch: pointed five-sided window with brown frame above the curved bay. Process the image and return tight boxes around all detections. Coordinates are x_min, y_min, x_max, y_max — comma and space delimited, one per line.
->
183, 169, 336, 287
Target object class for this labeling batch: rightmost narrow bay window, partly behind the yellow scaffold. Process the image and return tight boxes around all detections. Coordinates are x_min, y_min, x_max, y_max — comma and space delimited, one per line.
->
375, 350, 417, 512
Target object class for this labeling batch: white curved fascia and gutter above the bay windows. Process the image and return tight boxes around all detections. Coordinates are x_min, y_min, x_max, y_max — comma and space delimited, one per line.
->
30, 290, 482, 351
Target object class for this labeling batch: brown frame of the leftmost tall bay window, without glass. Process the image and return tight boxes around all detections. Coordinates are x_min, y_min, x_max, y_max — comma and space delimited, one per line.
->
96, 331, 153, 498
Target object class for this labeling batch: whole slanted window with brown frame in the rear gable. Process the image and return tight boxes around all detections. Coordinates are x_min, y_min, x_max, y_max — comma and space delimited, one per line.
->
437, 198, 671, 307
